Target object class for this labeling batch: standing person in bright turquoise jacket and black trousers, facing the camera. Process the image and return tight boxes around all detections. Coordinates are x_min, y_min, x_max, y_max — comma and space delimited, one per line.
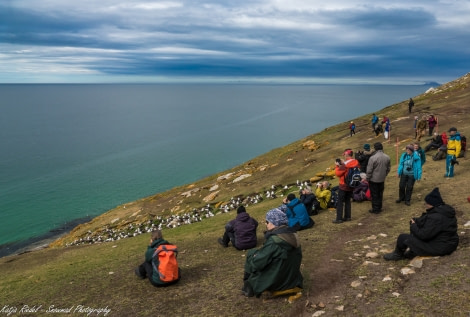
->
396, 144, 422, 206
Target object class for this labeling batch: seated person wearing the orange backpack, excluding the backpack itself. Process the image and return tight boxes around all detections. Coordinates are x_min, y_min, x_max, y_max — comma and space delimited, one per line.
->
135, 230, 181, 287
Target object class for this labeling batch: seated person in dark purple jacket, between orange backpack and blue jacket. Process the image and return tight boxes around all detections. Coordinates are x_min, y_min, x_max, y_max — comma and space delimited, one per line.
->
217, 205, 258, 250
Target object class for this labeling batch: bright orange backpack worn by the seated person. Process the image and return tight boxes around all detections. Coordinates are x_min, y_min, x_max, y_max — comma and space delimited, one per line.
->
152, 244, 179, 283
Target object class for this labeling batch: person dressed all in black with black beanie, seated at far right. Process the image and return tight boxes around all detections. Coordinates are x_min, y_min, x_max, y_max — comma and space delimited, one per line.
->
384, 187, 459, 261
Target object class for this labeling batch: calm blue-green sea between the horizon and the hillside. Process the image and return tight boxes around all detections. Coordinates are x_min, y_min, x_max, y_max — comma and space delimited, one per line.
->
0, 84, 429, 254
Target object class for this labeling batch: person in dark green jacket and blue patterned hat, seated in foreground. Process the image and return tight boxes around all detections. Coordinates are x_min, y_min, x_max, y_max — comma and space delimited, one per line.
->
242, 208, 303, 297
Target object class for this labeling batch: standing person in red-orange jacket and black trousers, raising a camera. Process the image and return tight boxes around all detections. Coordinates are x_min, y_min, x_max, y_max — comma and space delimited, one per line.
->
333, 149, 359, 223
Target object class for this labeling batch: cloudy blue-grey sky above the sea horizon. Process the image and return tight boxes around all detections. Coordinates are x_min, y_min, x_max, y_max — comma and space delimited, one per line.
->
0, 0, 470, 84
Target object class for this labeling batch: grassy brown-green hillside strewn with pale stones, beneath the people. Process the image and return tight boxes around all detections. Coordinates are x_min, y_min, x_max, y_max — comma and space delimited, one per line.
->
0, 74, 470, 316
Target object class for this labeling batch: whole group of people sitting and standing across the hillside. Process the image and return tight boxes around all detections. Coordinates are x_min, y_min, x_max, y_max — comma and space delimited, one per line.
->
135, 107, 461, 297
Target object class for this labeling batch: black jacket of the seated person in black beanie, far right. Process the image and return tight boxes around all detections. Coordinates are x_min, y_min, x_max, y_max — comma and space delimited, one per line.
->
407, 204, 459, 256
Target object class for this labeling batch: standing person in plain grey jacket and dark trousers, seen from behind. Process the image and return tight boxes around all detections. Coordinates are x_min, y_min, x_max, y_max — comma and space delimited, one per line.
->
366, 142, 391, 214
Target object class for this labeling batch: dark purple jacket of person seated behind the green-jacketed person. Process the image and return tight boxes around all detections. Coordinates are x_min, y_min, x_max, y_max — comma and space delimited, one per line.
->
227, 212, 258, 250
